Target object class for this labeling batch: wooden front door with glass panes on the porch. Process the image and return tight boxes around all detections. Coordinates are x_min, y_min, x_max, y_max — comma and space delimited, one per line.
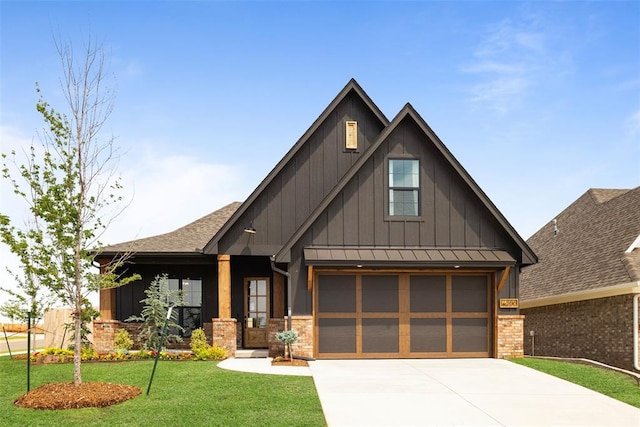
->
243, 277, 269, 348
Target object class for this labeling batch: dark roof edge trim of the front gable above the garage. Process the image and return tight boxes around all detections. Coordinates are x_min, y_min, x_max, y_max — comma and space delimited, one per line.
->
276, 103, 537, 265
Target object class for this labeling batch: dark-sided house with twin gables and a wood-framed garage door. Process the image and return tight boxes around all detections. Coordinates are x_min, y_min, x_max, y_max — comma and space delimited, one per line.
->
98, 80, 536, 358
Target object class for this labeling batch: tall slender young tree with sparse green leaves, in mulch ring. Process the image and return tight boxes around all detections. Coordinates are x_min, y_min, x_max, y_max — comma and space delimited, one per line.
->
0, 36, 136, 385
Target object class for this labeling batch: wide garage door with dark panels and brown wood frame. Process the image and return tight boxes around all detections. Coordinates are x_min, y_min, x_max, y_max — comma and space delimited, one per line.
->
314, 273, 491, 358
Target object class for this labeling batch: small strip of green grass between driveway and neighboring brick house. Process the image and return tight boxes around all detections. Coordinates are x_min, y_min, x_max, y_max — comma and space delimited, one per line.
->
511, 358, 640, 408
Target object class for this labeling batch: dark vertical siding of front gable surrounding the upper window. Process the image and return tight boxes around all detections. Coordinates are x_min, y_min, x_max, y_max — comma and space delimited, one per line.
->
308, 120, 514, 249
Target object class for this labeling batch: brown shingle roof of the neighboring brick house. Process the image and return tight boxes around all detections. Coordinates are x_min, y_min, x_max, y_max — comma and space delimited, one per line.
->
520, 187, 640, 301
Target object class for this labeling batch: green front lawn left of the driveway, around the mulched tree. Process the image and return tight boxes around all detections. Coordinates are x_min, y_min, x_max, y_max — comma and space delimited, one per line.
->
0, 357, 326, 427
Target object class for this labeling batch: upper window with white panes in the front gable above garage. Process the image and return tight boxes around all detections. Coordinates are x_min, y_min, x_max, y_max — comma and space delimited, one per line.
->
389, 159, 420, 216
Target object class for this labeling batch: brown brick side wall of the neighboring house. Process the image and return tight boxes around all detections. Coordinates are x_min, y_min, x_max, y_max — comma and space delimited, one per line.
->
521, 295, 633, 370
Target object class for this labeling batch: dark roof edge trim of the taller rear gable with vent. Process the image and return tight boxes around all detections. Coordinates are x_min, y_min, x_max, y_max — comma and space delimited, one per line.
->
204, 79, 389, 253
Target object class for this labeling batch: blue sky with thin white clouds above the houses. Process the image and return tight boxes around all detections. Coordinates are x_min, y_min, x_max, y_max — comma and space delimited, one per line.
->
0, 0, 640, 312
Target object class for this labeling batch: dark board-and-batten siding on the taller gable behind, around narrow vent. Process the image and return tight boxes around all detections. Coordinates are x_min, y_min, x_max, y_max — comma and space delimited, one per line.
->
218, 92, 385, 255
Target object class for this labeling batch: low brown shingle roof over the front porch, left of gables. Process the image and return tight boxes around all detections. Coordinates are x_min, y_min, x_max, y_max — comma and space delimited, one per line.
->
101, 202, 241, 255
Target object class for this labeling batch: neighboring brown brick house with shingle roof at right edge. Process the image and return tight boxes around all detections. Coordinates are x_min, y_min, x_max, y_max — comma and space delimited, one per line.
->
520, 187, 640, 369
